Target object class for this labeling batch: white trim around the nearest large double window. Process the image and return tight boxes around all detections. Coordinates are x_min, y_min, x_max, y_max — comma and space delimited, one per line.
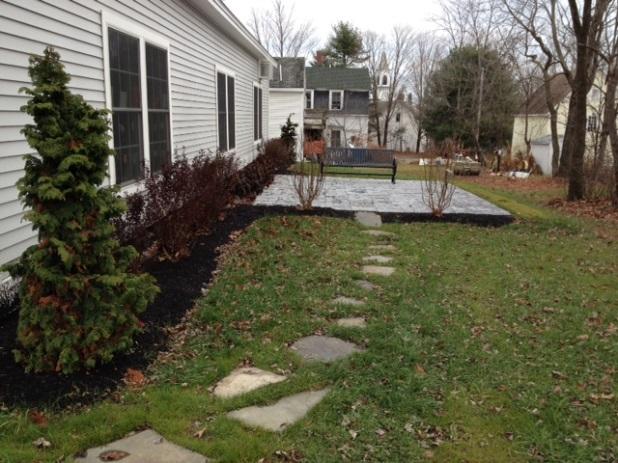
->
101, 10, 174, 188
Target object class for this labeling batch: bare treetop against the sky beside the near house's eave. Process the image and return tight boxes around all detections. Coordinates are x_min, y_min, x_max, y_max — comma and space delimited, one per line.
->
248, 0, 318, 58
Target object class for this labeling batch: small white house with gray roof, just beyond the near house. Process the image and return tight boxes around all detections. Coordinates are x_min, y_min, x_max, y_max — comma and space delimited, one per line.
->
268, 58, 305, 159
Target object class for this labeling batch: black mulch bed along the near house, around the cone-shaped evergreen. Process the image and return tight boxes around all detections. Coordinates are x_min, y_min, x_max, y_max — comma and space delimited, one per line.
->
0, 206, 266, 408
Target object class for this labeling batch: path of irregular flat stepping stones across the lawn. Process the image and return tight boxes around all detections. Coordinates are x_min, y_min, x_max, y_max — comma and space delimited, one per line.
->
75, 213, 404, 463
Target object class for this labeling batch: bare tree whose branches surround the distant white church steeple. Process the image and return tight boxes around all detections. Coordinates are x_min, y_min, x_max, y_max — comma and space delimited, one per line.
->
364, 26, 414, 146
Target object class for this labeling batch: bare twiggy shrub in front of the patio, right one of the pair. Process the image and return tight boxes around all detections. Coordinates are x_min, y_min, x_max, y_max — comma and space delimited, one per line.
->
421, 158, 455, 217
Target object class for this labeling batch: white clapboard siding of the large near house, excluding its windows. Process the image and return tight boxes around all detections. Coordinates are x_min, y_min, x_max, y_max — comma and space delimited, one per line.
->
0, 0, 269, 272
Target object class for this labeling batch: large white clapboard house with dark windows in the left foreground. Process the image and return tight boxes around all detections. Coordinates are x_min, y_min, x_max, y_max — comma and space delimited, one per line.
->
0, 0, 276, 272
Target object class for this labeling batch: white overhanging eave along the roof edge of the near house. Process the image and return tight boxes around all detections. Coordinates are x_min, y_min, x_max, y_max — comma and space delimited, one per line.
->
188, 0, 275, 66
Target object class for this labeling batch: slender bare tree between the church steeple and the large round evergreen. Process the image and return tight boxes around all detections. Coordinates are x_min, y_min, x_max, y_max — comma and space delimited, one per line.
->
408, 32, 444, 153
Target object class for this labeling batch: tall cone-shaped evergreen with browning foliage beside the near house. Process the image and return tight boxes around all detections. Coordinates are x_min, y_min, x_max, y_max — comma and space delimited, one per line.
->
7, 47, 158, 373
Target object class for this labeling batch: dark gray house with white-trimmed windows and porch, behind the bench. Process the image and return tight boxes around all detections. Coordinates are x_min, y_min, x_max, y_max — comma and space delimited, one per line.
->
304, 67, 371, 147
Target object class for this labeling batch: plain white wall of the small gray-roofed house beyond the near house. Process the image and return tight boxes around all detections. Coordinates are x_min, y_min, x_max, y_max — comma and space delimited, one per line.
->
268, 88, 305, 159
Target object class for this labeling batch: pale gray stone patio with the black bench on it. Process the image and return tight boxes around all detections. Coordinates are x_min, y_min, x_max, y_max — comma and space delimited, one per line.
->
255, 175, 511, 219
